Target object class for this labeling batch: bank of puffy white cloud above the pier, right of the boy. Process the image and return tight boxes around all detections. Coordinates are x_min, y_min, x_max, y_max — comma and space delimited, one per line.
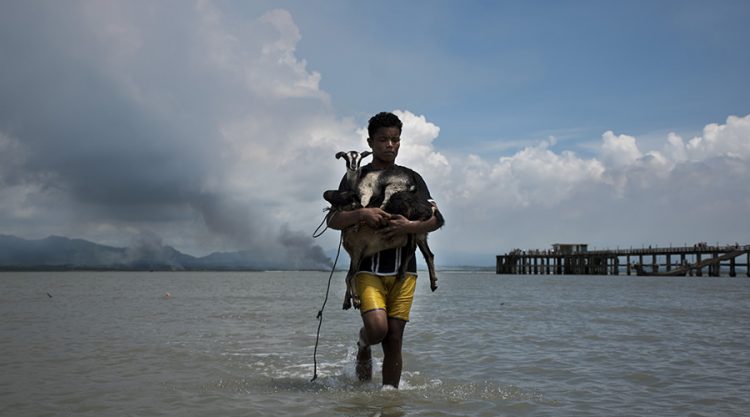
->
435, 115, 750, 260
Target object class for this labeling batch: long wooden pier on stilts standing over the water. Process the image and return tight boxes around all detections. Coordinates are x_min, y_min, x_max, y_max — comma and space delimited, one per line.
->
496, 244, 750, 277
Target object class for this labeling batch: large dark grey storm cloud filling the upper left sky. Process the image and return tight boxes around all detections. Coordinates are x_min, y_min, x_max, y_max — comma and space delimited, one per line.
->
0, 2, 334, 267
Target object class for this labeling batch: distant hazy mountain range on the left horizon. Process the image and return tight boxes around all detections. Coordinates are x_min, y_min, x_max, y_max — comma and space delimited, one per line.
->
0, 235, 314, 271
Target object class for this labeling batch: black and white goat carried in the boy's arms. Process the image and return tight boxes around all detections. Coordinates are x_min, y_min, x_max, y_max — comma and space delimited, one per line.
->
323, 151, 443, 310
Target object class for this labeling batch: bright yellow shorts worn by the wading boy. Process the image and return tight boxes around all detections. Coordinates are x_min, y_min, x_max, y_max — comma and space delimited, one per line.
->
354, 272, 417, 321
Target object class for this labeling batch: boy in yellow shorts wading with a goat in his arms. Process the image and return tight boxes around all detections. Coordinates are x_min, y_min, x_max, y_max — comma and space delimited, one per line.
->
328, 112, 442, 387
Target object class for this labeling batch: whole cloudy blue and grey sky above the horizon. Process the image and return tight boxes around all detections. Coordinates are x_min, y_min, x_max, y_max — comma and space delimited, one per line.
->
0, 0, 750, 268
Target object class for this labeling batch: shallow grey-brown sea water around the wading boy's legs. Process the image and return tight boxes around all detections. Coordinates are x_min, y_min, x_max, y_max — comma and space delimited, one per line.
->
0, 272, 750, 417
